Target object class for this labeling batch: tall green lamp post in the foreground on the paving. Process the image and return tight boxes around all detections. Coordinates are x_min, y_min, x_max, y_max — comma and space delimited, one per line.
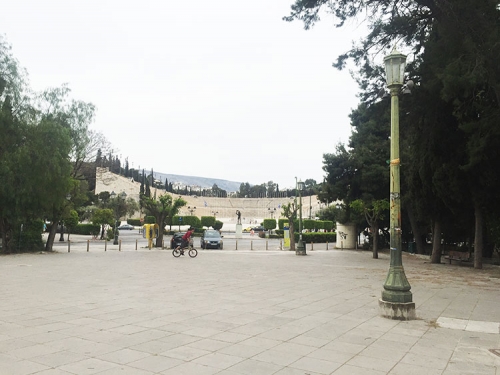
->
379, 47, 415, 320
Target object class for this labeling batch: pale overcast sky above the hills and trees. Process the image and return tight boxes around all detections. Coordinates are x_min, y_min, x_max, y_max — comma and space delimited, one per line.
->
0, 0, 366, 188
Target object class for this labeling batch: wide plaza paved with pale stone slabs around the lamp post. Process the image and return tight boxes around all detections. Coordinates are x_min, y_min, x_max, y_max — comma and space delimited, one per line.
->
0, 242, 500, 375
